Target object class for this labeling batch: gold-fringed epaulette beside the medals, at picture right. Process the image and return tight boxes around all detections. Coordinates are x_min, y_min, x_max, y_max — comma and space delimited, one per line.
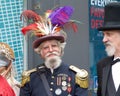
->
69, 65, 88, 88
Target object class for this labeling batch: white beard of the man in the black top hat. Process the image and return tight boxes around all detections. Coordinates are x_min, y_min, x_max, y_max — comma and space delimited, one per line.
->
105, 43, 115, 56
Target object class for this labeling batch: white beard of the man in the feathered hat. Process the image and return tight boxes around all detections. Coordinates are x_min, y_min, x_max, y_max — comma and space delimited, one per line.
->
45, 56, 62, 69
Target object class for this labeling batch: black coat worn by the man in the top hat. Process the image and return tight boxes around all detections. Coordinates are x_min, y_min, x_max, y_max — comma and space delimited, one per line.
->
97, 57, 113, 96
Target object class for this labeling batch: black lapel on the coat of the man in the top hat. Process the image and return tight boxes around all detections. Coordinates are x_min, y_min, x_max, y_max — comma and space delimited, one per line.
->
102, 58, 113, 96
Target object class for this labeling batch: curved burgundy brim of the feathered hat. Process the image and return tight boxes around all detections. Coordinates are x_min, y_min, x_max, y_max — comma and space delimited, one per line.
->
33, 36, 65, 48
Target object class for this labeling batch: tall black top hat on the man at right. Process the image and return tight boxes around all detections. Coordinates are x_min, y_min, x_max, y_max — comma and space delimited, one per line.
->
98, 2, 120, 31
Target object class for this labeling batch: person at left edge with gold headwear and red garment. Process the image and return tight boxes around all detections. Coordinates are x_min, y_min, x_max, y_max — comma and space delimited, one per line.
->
0, 42, 20, 96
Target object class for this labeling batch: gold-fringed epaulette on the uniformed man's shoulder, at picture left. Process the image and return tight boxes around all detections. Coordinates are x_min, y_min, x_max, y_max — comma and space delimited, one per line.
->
21, 68, 37, 87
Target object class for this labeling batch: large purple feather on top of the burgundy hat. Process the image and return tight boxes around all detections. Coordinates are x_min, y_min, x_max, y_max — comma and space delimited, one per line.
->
49, 6, 74, 26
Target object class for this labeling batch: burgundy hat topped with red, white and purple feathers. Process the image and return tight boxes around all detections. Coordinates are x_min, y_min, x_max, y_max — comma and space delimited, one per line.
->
20, 6, 77, 48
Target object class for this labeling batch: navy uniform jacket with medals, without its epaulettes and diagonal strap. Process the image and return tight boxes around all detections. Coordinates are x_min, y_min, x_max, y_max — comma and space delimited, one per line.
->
20, 64, 88, 96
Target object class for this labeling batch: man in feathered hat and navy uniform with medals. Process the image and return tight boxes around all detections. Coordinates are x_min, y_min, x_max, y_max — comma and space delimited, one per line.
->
20, 6, 88, 96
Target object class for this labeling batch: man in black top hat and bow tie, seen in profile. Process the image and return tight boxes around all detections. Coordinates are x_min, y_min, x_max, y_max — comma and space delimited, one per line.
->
97, 2, 120, 96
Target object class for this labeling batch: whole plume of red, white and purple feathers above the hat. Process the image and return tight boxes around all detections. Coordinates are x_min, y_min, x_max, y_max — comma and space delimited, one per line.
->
20, 6, 77, 37
